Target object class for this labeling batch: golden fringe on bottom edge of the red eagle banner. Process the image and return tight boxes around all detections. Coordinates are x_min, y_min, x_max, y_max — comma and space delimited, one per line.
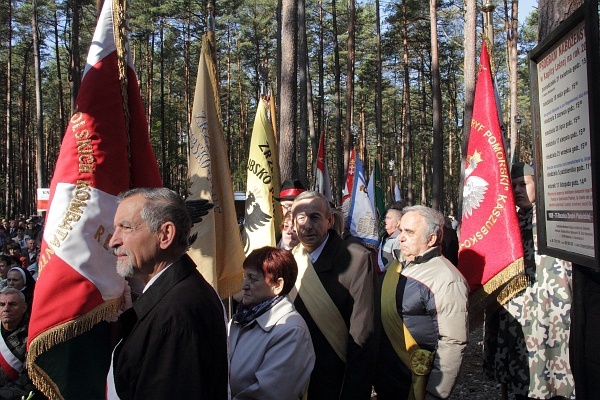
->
469, 257, 529, 325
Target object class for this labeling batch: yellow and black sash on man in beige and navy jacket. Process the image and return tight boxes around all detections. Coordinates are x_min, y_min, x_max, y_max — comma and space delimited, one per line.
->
381, 260, 434, 400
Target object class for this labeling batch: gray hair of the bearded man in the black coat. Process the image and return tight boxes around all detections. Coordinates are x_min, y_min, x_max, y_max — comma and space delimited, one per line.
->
119, 188, 192, 254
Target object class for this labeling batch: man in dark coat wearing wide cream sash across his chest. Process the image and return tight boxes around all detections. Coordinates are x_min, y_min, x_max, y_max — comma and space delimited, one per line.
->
292, 191, 375, 400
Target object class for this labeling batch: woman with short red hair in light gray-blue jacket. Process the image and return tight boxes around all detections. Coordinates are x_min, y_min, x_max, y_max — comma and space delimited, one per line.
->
229, 247, 315, 400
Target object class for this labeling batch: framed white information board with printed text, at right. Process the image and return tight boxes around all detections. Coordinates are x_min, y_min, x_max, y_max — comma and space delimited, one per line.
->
537, 21, 595, 257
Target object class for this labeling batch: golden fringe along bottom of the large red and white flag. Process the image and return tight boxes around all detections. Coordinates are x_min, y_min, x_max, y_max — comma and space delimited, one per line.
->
27, 298, 123, 400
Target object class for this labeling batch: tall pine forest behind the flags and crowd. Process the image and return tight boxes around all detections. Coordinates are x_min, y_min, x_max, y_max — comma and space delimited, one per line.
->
0, 0, 537, 216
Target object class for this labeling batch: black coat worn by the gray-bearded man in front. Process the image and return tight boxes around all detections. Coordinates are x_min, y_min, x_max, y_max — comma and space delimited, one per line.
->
113, 255, 228, 400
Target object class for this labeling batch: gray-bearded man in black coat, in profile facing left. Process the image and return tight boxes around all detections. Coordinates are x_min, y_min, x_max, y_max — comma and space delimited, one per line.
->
107, 188, 228, 399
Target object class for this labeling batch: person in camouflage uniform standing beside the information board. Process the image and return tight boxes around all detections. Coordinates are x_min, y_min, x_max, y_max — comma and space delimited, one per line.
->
484, 162, 575, 400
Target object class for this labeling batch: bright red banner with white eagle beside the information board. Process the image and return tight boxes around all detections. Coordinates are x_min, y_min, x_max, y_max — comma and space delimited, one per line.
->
458, 43, 524, 318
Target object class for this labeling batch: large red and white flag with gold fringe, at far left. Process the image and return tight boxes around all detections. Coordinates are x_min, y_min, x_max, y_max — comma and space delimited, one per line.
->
27, 0, 162, 399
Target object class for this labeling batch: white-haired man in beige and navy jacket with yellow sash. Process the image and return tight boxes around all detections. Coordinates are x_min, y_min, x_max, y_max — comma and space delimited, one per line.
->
374, 206, 469, 400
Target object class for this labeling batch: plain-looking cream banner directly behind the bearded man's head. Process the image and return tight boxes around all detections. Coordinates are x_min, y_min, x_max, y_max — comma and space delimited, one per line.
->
188, 35, 245, 298
